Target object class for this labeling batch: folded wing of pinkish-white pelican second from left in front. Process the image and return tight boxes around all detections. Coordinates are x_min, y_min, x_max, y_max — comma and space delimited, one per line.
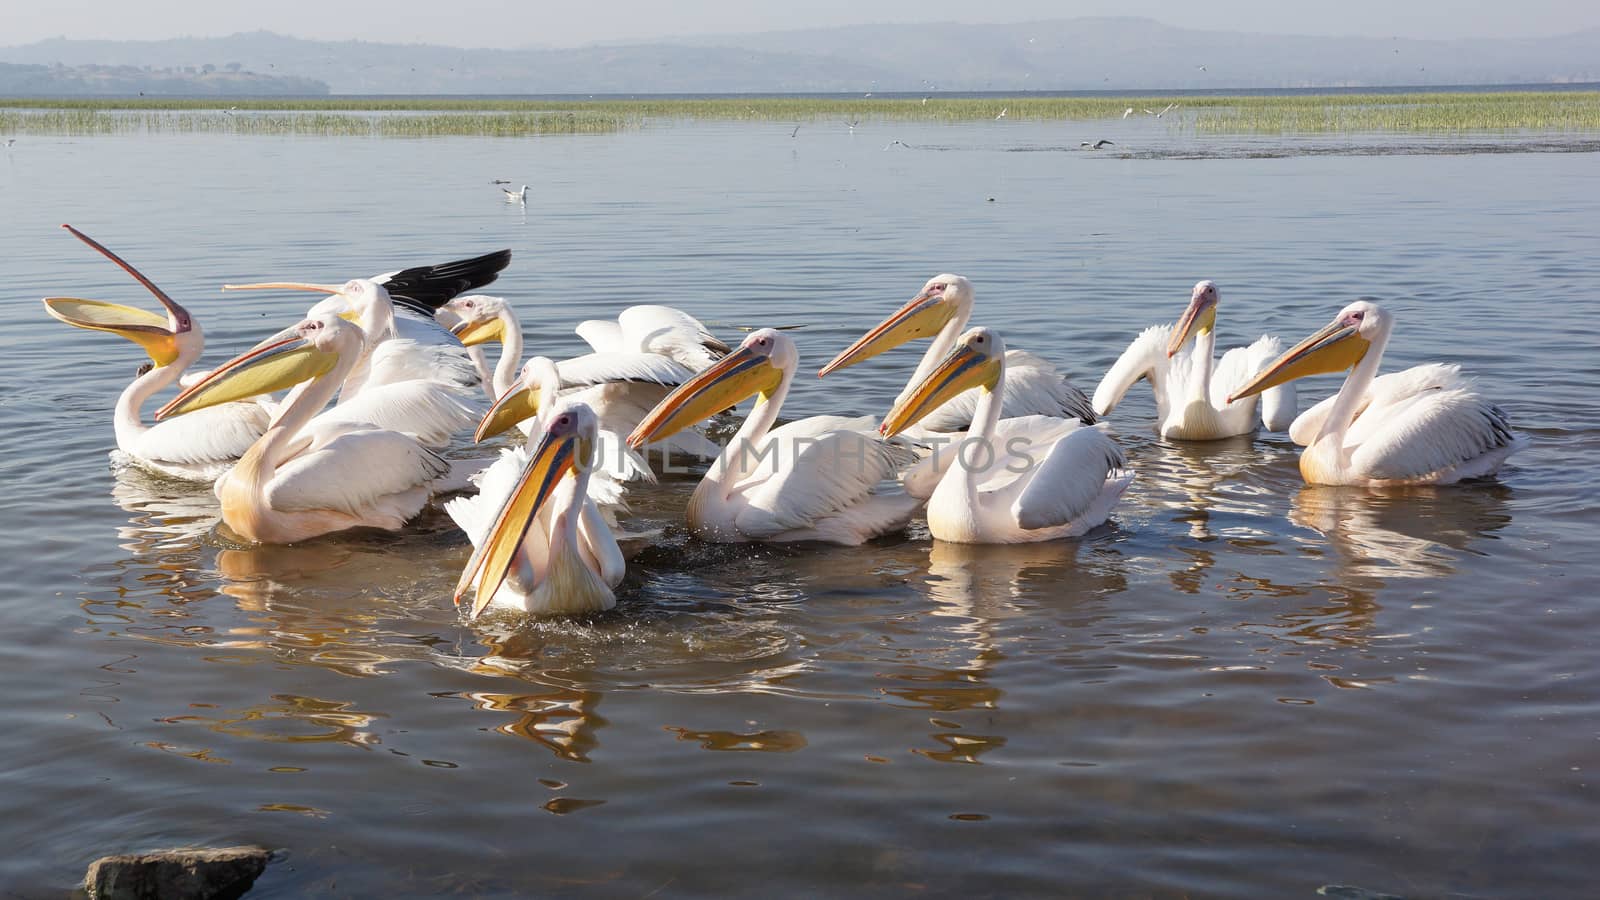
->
266, 429, 450, 519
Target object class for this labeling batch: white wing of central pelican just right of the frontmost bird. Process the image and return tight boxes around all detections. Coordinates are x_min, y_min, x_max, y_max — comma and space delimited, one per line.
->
728, 416, 909, 540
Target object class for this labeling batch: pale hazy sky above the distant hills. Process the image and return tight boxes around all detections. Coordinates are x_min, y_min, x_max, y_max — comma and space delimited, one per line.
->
12, 0, 1600, 46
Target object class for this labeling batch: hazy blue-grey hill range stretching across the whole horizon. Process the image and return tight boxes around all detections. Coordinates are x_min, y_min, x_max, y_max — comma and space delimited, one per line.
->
0, 18, 1600, 94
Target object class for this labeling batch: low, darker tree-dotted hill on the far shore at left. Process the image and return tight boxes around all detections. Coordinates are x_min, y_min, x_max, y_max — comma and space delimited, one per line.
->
0, 62, 328, 96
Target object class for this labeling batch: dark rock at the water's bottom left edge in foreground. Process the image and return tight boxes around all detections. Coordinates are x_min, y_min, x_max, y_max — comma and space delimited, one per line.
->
83, 847, 272, 900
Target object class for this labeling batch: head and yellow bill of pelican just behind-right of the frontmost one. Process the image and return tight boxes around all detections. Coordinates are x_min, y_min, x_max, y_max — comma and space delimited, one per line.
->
627, 328, 800, 450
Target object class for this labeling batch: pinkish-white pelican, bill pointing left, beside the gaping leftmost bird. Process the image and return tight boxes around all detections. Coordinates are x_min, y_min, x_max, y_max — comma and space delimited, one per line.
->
155, 315, 450, 543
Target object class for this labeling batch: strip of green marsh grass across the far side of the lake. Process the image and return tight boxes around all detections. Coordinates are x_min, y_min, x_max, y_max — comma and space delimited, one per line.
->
0, 91, 1600, 138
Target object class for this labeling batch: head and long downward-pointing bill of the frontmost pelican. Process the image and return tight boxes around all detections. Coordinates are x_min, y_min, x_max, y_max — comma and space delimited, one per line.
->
454, 402, 600, 617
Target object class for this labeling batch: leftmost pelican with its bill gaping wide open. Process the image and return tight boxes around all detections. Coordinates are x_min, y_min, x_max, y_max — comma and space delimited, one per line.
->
45, 226, 269, 482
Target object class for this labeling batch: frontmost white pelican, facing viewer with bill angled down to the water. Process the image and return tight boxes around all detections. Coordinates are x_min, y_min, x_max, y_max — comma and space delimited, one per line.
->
457, 404, 624, 617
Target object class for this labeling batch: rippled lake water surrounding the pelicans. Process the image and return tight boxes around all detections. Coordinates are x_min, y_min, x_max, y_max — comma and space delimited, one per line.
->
0, 120, 1600, 897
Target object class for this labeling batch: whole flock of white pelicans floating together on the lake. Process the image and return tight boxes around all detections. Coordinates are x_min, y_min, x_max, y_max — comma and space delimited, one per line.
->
45, 226, 1522, 617
